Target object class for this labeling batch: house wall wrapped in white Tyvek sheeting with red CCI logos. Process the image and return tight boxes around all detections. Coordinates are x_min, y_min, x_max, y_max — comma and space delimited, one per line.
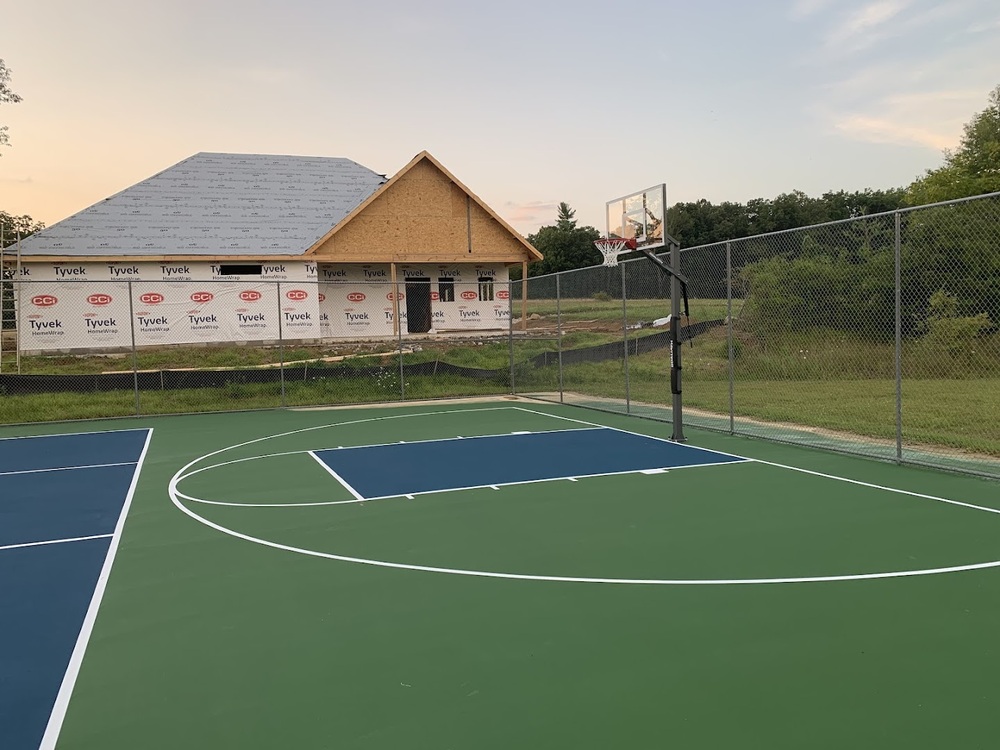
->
18, 260, 509, 352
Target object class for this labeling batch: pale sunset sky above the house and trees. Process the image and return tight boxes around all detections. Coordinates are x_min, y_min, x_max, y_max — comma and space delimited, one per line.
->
0, 0, 1000, 235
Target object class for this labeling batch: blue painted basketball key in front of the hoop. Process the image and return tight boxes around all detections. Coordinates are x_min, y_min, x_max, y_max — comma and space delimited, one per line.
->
313, 428, 746, 500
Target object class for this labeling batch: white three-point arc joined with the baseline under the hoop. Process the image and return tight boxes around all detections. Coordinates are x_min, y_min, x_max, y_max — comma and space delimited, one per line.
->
167, 406, 1000, 586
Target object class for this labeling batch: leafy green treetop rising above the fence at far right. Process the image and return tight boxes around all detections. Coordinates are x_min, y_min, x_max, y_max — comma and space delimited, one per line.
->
907, 86, 1000, 205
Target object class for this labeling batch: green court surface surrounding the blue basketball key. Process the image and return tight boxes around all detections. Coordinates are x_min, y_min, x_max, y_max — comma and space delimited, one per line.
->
0, 399, 1000, 750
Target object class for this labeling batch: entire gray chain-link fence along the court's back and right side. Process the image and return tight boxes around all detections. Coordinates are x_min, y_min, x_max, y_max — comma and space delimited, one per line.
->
0, 195, 1000, 477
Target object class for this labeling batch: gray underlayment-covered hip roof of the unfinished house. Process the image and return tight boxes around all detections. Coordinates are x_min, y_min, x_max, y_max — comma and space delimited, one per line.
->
21, 153, 386, 257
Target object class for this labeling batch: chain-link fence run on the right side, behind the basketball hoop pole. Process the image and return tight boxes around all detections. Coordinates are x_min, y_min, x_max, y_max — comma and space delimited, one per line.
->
531, 195, 1000, 477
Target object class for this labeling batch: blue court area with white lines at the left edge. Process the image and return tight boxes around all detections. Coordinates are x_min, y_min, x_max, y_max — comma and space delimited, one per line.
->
0, 430, 150, 750
